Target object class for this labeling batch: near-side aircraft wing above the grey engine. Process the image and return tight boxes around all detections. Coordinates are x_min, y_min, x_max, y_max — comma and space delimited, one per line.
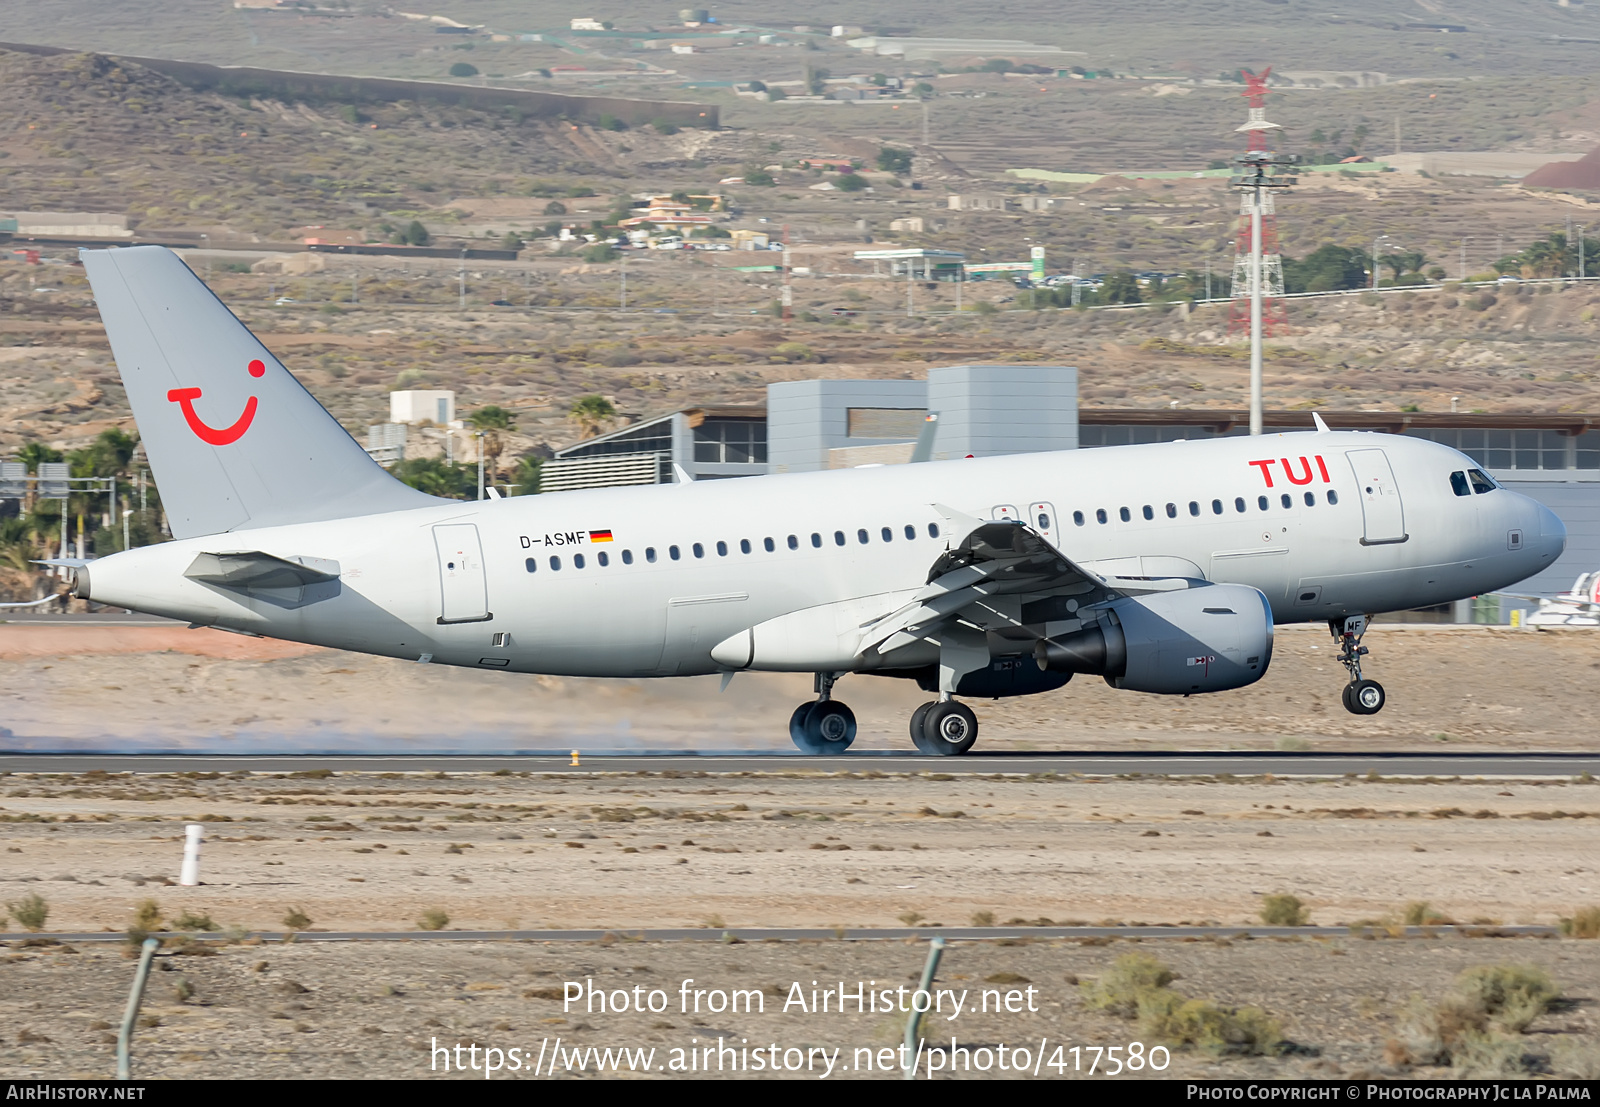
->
859, 520, 1126, 654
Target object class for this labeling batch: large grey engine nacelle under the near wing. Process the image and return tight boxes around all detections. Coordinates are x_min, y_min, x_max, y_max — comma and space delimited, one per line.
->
1034, 584, 1272, 696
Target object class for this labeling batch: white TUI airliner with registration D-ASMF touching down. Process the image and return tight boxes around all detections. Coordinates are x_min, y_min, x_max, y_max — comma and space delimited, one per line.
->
74, 246, 1566, 755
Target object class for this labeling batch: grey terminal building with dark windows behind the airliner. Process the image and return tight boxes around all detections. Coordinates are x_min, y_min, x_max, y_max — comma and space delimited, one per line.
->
541, 365, 1600, 622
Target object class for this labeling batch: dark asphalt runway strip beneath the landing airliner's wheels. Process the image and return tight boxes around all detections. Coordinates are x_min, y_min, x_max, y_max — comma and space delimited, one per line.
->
0, 750, 1600, 777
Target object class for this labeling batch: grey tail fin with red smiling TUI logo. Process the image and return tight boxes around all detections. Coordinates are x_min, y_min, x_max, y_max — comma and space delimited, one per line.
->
82, 246, 435, 538
